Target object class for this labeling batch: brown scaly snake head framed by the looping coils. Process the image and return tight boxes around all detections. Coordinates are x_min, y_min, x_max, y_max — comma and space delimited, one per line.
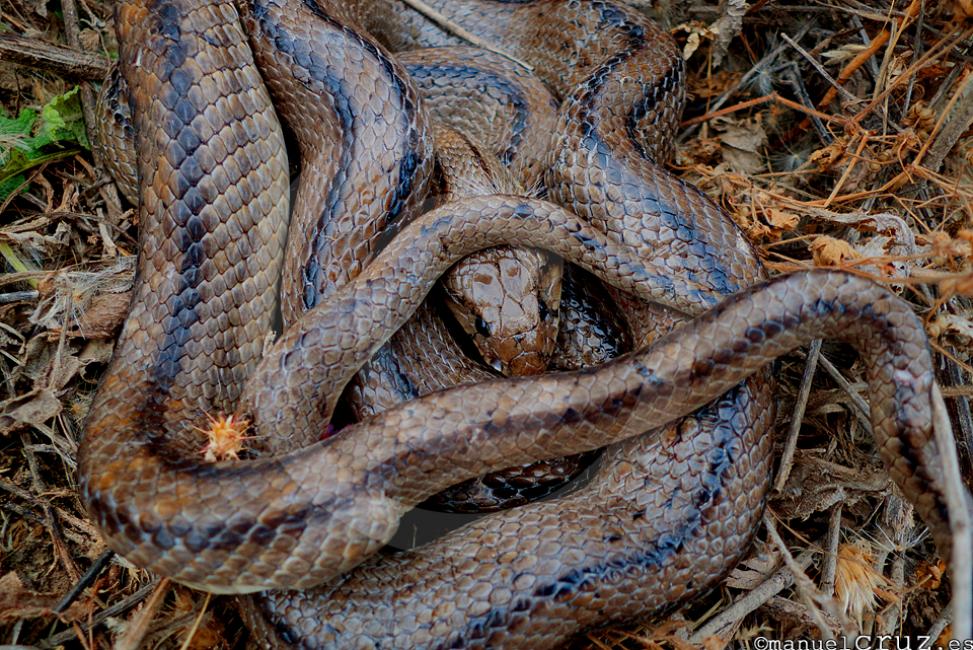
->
443, 247, 562, 376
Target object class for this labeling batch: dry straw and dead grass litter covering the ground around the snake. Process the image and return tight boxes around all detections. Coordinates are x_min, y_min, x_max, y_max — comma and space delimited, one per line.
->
0, 0, 973, 648
